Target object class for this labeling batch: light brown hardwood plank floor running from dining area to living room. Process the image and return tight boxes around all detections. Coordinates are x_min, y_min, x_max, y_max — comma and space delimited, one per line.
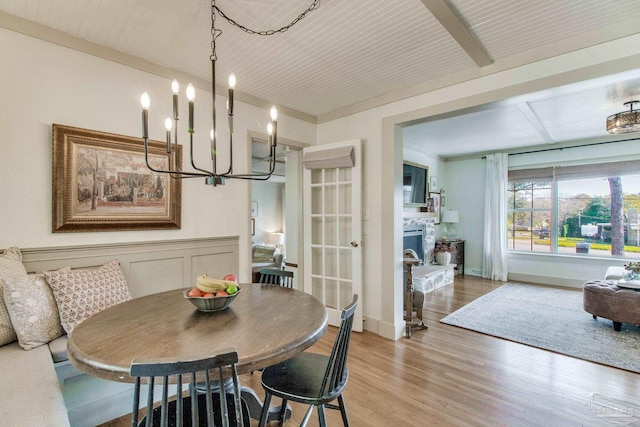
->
103, 276, 640, 427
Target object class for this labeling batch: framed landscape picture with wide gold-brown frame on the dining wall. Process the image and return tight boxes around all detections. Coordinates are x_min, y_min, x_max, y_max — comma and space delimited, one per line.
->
52, 124, 182, 233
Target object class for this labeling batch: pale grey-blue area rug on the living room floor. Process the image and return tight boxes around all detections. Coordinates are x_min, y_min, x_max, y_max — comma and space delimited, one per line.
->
441, 283, 640, 373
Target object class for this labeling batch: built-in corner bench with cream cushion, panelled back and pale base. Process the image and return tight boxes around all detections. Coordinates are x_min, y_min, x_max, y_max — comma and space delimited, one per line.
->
0, 237, 239, 427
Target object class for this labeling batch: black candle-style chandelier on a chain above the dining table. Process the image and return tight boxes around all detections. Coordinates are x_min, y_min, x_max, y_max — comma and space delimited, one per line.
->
140, 0, 320, 186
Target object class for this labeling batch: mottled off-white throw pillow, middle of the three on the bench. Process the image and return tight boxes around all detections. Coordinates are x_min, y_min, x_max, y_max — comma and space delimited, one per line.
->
4, 274, 63, 350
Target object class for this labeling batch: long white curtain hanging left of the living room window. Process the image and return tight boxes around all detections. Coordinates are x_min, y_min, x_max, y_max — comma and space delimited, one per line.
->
482, 153, 508, 281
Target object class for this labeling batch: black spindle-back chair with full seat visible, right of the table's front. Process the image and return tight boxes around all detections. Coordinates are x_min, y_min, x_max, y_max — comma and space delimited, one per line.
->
259, 295, 358, 427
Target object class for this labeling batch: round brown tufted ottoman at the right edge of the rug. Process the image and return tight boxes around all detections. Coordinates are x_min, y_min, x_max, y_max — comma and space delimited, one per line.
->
582, 280, 640, 331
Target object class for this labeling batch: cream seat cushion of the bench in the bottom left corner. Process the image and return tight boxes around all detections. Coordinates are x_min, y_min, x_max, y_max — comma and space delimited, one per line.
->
0, 343, 69, 427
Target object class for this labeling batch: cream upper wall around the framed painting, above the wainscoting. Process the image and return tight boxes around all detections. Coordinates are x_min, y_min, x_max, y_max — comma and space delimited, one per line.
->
0, 29, 316, 280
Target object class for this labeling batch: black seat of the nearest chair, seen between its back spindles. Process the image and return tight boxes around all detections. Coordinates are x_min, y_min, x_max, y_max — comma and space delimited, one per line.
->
138, 392, 251, 427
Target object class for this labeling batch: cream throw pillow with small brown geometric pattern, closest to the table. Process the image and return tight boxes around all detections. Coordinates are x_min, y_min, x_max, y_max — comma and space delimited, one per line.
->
44, 261, 131, 334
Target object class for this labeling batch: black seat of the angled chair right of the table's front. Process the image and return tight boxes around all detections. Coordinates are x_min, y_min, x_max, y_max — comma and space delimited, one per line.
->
262, 352, 349, 404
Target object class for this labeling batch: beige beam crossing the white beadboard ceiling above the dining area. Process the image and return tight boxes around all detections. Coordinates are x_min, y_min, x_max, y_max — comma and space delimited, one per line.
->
421, 0, 493, 67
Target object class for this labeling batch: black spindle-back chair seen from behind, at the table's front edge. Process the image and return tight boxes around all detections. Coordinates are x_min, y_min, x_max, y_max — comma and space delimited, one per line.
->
129, 351, 250, 427
